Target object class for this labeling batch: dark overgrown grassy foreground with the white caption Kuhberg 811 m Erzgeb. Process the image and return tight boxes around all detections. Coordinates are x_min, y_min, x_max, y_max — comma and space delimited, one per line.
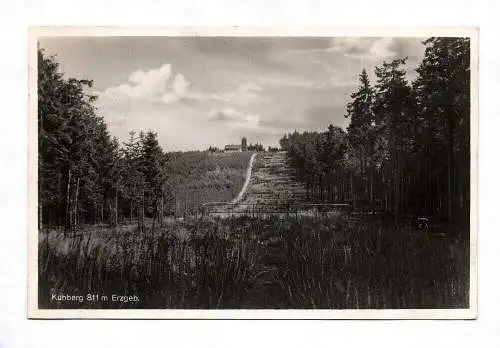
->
39, 216, 469, 309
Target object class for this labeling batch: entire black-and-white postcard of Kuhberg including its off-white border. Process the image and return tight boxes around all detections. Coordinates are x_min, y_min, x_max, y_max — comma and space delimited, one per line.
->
29, 28, 478, 319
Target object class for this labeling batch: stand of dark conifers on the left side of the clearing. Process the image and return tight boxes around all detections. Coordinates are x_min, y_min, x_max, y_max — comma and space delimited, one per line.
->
38, 49, 172, 232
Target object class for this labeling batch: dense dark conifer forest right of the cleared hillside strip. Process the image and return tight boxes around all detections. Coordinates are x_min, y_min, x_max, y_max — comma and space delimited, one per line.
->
280, 38, 470, 237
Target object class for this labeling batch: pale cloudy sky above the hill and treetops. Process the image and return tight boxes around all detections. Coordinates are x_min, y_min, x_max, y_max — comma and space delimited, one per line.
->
39, 37, 425, 151
